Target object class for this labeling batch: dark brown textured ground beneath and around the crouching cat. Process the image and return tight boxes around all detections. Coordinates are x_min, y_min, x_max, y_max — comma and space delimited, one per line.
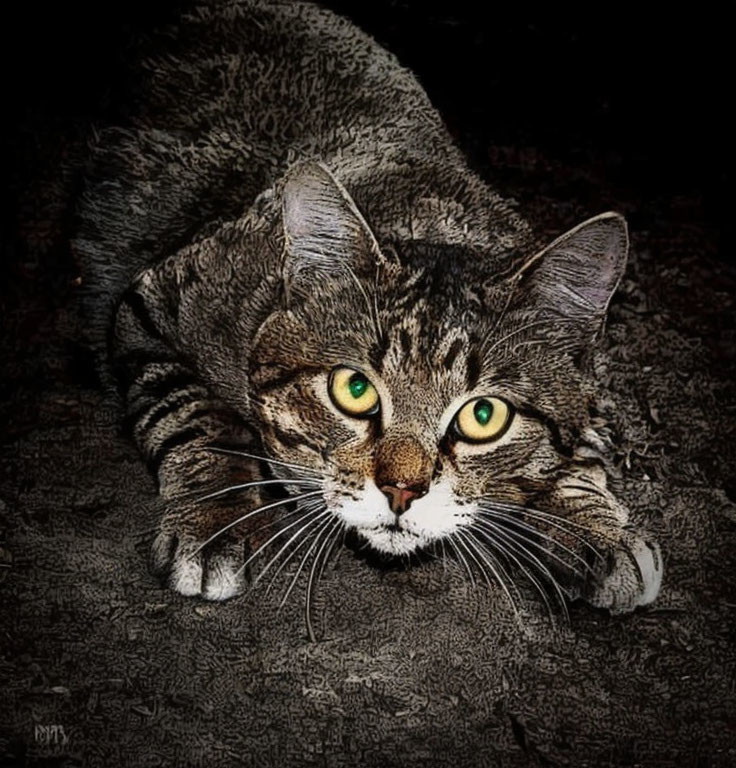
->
0, 7, 736, 768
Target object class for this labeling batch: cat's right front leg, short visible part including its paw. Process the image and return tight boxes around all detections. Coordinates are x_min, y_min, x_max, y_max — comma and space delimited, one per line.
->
547, 466, 663, 613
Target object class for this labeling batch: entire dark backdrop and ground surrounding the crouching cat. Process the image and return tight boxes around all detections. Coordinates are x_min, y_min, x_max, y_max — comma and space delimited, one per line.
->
0, 6, 736, 768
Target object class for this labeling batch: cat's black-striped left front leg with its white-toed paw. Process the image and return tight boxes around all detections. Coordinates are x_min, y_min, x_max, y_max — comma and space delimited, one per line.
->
112, 285, 268, 600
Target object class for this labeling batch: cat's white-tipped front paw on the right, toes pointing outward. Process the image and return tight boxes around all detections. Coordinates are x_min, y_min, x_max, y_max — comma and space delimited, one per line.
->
581, 537, 663, 613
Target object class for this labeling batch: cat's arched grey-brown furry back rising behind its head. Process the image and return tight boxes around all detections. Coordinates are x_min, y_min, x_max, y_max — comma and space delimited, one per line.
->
75, 0, 526, 366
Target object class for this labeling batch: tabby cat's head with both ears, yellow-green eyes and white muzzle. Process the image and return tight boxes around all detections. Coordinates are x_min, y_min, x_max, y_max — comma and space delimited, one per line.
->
250, 164, 628, 554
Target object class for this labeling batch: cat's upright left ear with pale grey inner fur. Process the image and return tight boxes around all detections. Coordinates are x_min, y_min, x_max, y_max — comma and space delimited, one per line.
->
282, 162, 383, 302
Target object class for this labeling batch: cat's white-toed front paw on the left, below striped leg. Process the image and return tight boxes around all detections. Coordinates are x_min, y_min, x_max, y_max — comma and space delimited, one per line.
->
151, 521, 246, 600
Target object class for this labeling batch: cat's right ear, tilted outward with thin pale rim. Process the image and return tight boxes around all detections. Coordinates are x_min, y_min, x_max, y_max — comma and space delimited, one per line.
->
515, 213, 629, 328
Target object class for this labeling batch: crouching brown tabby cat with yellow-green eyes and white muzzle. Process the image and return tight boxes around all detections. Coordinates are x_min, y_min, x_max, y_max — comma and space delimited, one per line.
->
73, 0, 662, 613
